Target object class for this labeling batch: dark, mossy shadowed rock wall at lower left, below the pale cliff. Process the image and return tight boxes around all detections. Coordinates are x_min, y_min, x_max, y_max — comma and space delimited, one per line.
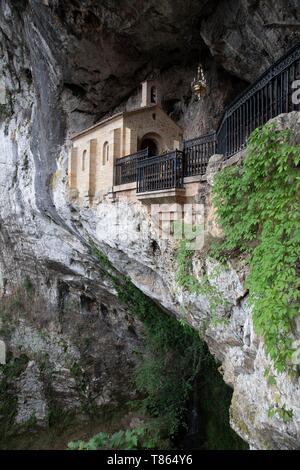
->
0, 273, 142, 435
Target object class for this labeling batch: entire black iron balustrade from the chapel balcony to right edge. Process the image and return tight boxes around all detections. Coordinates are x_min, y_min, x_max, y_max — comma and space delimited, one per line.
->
116, 44, 300, 193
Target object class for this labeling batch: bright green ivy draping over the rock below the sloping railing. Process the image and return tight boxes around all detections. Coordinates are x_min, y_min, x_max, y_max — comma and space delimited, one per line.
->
213, 124, 300, 371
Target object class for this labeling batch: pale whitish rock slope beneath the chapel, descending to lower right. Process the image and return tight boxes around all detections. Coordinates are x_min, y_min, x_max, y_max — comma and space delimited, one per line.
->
91, 113, 300, 449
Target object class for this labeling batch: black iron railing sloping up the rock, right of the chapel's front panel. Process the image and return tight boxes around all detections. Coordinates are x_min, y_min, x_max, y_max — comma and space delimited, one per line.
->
184, 44, 300, 176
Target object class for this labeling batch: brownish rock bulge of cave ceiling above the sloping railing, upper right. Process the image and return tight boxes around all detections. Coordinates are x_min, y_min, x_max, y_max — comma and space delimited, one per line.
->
201, 0, 299, 81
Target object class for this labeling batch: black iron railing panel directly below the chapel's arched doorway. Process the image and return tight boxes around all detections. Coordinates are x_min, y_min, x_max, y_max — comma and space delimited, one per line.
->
137, 150, 183, 193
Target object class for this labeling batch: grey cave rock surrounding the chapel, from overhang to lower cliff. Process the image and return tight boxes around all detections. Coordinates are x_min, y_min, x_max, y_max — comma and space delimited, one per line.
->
0, 0, 300, 448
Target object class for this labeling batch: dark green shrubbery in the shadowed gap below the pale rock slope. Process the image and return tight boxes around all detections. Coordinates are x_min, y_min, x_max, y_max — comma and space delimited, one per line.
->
117, 279, 203, 439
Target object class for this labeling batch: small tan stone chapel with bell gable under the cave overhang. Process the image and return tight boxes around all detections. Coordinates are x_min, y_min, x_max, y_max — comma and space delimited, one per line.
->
69, 80, 182, 205
